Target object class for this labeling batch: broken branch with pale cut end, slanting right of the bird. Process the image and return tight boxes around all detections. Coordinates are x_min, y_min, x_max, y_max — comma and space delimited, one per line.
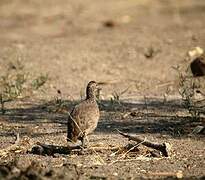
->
117, 129, 170, 157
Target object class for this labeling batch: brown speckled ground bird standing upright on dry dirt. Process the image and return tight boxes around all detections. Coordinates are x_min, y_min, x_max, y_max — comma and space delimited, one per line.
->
67, 81, 100, 147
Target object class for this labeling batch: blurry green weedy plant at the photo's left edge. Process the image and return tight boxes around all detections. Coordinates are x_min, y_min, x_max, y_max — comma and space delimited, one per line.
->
0, 61, 48, 114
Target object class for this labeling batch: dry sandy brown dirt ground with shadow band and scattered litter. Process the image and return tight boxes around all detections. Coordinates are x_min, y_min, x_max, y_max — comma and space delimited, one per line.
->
0, 0, 205, 179
